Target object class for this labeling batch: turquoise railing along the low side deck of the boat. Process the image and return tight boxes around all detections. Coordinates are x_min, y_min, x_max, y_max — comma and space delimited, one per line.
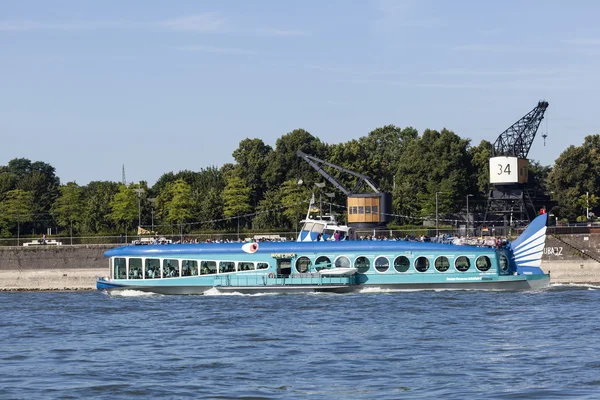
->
213, 272, 356, 287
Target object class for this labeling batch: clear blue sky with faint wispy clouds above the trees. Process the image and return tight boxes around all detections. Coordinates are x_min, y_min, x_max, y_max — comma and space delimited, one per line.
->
0, 0, 600, 185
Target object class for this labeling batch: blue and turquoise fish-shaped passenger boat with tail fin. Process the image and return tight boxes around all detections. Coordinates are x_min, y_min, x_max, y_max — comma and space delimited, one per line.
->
96, 214, 550, 294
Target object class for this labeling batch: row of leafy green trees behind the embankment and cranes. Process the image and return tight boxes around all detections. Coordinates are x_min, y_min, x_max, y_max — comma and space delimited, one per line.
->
0, 125, 600, 237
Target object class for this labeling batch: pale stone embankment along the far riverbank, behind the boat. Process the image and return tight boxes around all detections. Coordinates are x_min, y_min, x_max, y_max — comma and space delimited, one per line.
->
0, 234, 600, 291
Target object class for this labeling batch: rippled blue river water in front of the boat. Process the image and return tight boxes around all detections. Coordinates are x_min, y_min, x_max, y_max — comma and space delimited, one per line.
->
0, 286, 600, 399
